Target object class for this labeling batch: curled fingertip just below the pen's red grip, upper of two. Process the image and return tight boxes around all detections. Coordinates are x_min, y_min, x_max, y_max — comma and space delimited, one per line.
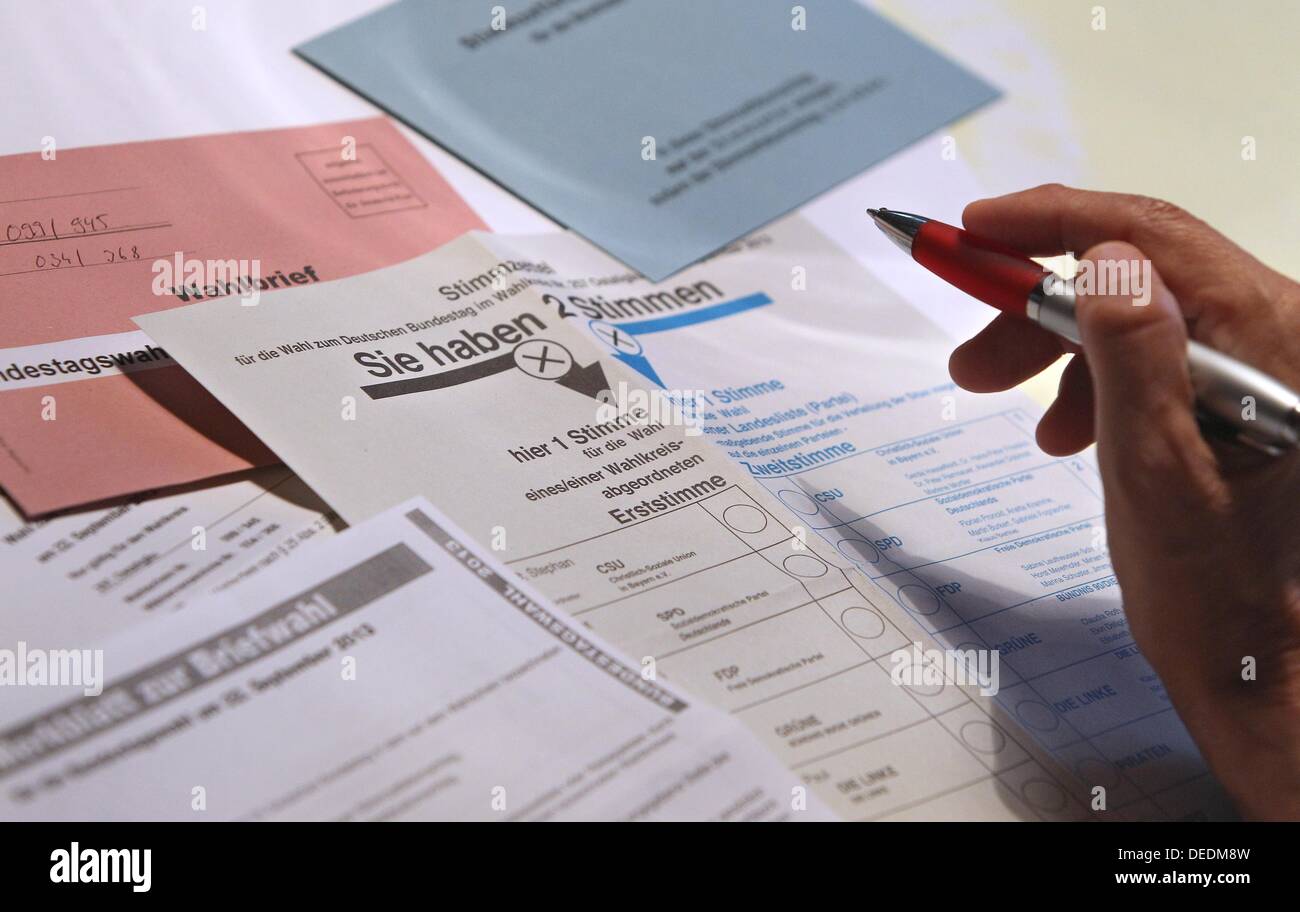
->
948, 313, 1069, 392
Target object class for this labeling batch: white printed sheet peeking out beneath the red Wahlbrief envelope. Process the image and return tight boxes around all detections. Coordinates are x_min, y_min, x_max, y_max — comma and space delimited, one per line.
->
0, 465, 342, 648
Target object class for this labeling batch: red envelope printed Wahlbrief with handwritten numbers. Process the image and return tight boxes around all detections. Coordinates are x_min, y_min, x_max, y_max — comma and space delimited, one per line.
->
0, 118, 482, 516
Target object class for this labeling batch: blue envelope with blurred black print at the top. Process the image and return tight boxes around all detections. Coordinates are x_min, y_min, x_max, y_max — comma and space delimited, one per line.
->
296, 0, 997, 279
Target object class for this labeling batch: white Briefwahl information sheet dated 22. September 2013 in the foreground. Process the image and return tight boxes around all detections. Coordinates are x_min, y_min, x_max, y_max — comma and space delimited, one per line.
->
0, 500, 832, 821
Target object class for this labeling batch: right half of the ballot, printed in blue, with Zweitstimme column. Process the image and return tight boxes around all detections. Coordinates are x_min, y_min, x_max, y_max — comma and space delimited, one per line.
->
484, 218, 1231, 818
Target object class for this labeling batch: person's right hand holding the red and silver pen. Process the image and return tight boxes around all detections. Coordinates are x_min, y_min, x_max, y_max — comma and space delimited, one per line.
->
949, 184, 1300, 820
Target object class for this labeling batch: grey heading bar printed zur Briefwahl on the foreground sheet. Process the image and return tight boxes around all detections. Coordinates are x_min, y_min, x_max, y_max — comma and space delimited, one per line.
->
0, 544, 433, 778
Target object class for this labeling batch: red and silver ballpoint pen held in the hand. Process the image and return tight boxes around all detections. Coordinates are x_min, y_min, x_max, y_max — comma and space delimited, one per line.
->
867, 203, 1300, 455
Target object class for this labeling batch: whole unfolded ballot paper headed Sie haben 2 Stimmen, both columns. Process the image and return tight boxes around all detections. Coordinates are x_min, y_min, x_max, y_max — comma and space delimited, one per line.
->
137, 217, 1226, 820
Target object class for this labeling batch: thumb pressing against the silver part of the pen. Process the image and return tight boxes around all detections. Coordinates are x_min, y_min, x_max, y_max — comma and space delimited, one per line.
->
1075, 242, 1222, 518
